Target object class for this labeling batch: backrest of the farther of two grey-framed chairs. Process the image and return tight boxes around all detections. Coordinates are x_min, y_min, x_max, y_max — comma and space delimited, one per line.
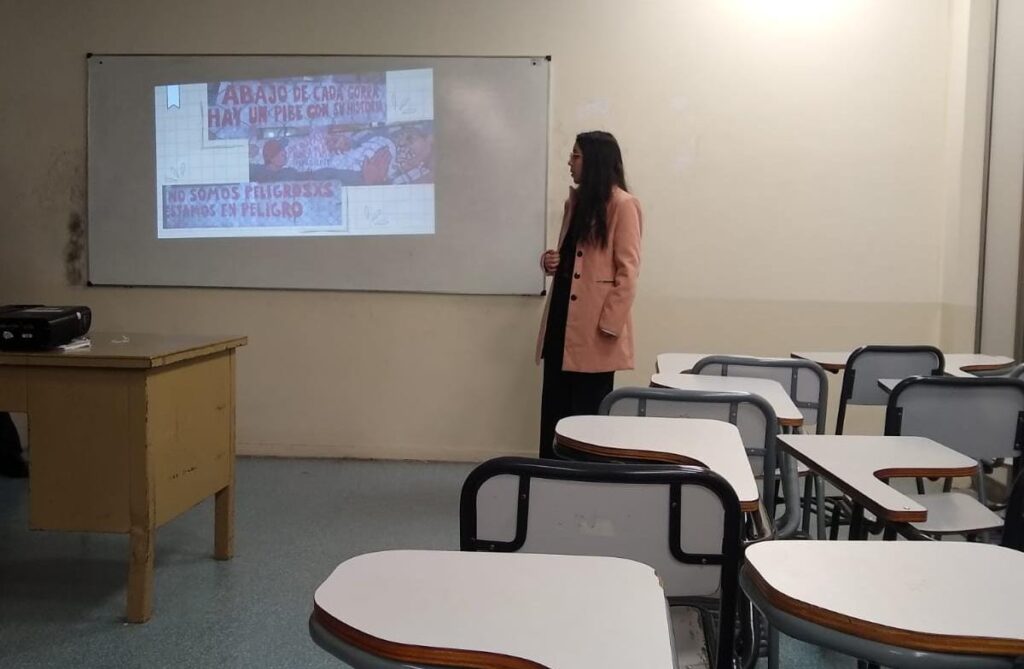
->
693, 356, 828, 434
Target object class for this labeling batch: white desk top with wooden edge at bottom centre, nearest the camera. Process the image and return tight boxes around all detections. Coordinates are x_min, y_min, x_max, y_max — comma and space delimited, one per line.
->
313, 550, 675, 669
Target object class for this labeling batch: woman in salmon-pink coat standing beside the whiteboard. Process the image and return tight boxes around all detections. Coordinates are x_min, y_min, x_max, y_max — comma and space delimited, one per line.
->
537, 131, 641, 458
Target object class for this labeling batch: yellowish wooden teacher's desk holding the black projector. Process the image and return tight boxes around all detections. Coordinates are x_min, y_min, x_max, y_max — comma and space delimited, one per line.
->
0, 333, 247, 623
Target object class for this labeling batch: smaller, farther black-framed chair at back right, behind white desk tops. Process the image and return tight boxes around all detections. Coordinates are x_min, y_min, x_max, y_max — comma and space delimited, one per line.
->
836, 345, 945, 434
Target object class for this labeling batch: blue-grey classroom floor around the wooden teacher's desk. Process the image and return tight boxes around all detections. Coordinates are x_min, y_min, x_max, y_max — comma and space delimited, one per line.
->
0, 458, 855, 669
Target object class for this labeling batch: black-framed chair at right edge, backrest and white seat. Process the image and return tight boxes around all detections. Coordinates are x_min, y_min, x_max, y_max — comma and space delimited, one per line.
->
886, 376, 1024, 536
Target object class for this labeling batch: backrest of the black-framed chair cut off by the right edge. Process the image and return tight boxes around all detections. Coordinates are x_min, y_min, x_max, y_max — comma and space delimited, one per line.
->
886, 376, 1024, 460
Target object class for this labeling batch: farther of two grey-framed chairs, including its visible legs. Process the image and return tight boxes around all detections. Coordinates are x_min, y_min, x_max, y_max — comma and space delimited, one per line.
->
693, 356, 828, 539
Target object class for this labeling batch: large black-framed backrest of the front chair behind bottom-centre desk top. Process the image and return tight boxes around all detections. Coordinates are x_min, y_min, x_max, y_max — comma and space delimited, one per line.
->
460, 457, 741, 667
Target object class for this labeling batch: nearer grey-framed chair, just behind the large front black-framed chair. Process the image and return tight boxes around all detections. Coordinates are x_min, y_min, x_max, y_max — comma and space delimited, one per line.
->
593, 387, 799, 537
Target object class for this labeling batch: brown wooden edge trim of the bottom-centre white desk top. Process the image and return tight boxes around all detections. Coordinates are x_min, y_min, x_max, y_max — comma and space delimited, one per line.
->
313, 603, 549, 669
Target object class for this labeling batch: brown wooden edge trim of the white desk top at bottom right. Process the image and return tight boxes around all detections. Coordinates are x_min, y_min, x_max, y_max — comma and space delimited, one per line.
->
745, 562, 1024, 656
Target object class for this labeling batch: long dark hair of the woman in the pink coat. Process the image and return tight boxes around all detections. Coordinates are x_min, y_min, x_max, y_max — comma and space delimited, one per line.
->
572, 130, 628, 248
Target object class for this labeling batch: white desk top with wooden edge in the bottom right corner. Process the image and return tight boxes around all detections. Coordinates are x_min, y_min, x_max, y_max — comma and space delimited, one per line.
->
744, 541, 1024, 656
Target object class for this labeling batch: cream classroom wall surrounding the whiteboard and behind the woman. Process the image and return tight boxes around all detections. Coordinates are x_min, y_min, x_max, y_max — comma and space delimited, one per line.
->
0, 0, 987, 460
